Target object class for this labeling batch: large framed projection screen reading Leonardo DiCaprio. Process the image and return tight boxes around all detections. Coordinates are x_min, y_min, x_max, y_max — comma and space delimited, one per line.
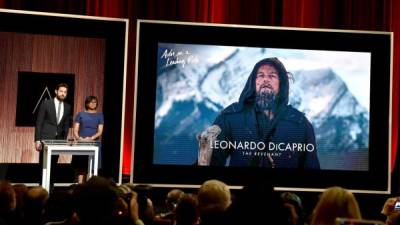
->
133, 20, 392, 193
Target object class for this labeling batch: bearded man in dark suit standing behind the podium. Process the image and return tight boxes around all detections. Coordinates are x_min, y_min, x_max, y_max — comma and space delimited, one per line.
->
35, 83, 71, 185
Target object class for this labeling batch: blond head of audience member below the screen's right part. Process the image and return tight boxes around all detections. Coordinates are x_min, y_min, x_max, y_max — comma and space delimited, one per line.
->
311, 187, 361, 225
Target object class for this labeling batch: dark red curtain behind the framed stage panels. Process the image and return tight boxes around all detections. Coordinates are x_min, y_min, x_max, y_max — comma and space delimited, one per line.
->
0, 0, 400, 182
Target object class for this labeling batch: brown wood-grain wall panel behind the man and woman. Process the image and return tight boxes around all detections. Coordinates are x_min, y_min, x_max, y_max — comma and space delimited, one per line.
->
0, 32, 105, 163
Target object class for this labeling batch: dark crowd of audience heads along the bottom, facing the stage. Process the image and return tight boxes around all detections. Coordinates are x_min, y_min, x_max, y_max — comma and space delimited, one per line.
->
5, 176, 400, 225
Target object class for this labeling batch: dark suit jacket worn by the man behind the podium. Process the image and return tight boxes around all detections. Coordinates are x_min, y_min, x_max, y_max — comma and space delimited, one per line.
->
35, 99, 71, 141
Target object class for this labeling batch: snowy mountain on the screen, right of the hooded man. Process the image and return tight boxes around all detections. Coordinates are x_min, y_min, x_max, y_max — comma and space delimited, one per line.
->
290, 68, 369, 170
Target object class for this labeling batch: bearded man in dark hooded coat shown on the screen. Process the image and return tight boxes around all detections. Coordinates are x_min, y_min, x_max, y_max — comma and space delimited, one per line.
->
198, 57, 320, 169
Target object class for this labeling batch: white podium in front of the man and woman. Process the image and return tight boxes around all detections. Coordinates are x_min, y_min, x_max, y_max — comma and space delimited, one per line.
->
42, 140, 99, 191
